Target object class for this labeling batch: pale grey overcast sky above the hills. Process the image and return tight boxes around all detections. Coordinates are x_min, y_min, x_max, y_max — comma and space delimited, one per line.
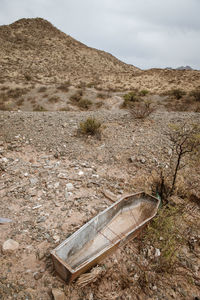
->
0, 0, 200, 69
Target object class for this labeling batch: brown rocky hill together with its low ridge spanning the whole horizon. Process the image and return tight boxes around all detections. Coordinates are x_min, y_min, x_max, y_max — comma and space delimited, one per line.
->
0, 18, 200, 93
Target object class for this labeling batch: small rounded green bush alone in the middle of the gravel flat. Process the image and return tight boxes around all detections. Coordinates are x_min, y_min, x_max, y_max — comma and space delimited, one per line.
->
79, 117, 101, 135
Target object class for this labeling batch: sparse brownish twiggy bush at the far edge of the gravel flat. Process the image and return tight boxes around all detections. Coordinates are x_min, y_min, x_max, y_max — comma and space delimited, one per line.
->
129, 102, 154, 119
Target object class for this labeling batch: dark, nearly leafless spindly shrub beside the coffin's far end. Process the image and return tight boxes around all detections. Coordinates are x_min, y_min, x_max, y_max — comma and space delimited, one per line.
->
153, 123, 200, 202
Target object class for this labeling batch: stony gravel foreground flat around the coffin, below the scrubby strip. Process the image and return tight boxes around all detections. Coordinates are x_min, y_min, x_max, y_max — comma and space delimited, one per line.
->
0, 109, 200, 300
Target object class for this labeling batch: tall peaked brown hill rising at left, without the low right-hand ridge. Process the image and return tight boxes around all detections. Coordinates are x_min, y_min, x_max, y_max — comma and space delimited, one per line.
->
0, 18, 137, 82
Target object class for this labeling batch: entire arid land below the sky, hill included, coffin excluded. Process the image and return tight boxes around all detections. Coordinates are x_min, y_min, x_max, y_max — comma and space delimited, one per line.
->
0, 19, 200, 300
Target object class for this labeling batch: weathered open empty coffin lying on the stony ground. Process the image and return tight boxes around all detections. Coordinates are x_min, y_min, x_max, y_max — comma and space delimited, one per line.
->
51, 192, 160, 282
